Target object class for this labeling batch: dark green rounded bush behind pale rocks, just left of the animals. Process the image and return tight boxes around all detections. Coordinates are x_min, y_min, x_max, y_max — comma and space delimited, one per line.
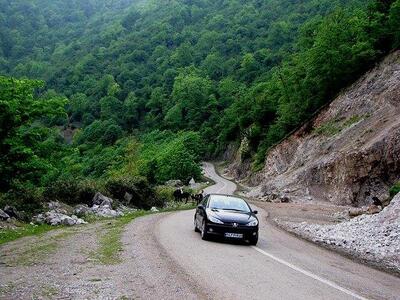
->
105, 176, 164, 209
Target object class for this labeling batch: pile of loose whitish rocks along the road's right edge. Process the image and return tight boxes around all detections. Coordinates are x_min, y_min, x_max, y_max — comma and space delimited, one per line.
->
275, 194, 400, 273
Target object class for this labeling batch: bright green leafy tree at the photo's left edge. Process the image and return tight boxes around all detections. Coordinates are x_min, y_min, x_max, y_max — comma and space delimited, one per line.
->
0, 76, 66, 192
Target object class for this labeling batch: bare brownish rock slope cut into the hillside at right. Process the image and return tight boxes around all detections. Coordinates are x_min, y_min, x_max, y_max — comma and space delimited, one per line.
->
231, 51, 400, 206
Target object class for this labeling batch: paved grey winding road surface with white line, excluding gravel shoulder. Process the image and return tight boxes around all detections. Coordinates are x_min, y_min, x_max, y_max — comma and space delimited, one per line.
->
153, 163, 400, 299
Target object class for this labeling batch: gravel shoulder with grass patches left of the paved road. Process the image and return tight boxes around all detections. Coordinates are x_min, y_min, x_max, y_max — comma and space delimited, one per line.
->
0, 213, 206, 299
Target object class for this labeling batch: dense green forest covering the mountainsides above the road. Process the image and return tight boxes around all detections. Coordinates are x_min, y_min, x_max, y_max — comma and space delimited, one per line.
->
0, 0, 400, 211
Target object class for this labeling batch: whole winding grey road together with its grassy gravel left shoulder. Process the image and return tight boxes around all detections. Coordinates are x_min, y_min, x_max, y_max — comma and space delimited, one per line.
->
0, 163, 400, 300
